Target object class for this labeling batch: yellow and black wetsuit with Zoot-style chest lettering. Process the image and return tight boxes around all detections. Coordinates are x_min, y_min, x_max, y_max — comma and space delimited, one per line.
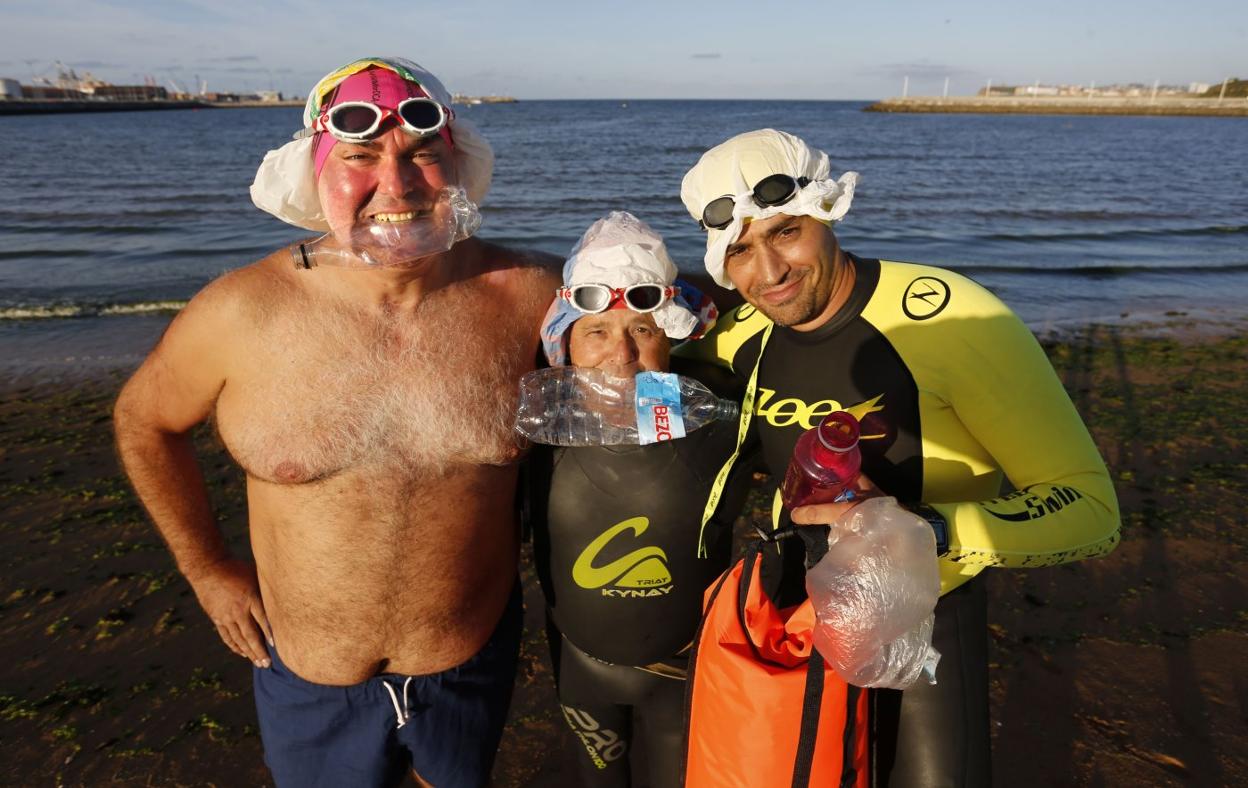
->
679, 255, 1118, 786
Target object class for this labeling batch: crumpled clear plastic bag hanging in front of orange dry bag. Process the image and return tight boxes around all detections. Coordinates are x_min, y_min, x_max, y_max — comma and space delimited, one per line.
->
806, 498, 940, 689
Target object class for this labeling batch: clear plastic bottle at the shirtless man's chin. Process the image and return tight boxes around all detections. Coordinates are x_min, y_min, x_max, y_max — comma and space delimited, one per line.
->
292, 186, 480, 268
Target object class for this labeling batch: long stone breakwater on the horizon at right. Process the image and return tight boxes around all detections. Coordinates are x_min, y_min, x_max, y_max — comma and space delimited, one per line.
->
864, 96, 1248, 117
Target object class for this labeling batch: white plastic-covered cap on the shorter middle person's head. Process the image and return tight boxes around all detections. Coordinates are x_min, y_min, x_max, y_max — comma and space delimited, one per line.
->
542, 211, 719, 366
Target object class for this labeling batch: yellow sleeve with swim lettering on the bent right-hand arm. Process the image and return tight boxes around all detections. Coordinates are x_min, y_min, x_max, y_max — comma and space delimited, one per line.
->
881, 266, 1119, 574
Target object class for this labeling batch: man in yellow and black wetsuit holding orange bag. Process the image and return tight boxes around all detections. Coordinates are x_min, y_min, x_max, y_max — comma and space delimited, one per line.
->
681, 129, 1118, 786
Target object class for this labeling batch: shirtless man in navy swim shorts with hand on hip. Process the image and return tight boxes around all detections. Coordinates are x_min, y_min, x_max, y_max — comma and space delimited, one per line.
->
115, 59, 559, 787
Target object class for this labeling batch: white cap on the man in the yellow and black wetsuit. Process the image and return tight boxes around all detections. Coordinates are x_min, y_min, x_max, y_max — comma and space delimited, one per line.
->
680, 129, 859, 290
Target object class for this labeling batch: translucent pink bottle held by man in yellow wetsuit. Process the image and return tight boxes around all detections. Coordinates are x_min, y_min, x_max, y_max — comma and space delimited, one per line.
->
780, 411, 862, 510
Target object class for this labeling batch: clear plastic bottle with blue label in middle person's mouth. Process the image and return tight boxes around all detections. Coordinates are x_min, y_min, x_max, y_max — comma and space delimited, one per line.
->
515, 367, 740, 446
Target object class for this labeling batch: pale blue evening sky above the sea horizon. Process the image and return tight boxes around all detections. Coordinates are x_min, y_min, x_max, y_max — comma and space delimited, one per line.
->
0, 0, 1248, 100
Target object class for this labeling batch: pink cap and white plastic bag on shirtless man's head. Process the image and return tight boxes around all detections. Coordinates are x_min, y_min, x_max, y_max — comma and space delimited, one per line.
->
251, 57, 494, 232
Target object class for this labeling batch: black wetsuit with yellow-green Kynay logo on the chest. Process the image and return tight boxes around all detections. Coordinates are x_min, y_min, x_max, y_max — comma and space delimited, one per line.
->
530, 422, 745, 786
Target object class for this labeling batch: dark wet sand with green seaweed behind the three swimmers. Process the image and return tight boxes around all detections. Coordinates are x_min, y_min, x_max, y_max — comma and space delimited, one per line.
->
0, 315, 1248, 787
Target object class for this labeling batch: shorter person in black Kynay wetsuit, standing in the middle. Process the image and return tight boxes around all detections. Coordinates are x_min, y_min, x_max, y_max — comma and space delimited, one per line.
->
528, 214, 744, 787
